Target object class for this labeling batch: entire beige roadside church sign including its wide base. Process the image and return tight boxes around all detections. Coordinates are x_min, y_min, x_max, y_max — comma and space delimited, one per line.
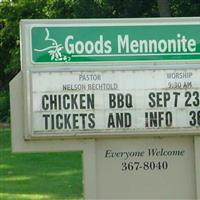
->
10, 18, 200, 199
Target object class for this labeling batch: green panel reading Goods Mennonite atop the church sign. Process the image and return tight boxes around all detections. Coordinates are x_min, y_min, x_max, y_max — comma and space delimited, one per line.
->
31, 24, 200, 63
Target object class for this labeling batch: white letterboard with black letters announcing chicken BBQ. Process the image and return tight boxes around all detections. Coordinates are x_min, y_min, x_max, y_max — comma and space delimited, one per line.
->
29, 70, 200, 136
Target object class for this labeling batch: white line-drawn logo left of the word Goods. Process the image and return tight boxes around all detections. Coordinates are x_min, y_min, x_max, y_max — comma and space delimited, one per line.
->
34, 28, 68, 61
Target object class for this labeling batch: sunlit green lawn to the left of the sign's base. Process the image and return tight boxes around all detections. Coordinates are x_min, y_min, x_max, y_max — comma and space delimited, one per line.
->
0, 129, 83, 200
